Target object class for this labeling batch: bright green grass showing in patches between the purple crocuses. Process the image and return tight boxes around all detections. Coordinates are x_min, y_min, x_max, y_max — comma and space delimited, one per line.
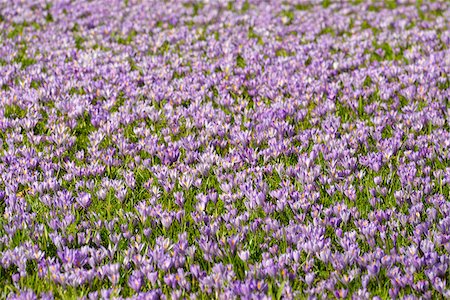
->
0, 0, 450, 299
